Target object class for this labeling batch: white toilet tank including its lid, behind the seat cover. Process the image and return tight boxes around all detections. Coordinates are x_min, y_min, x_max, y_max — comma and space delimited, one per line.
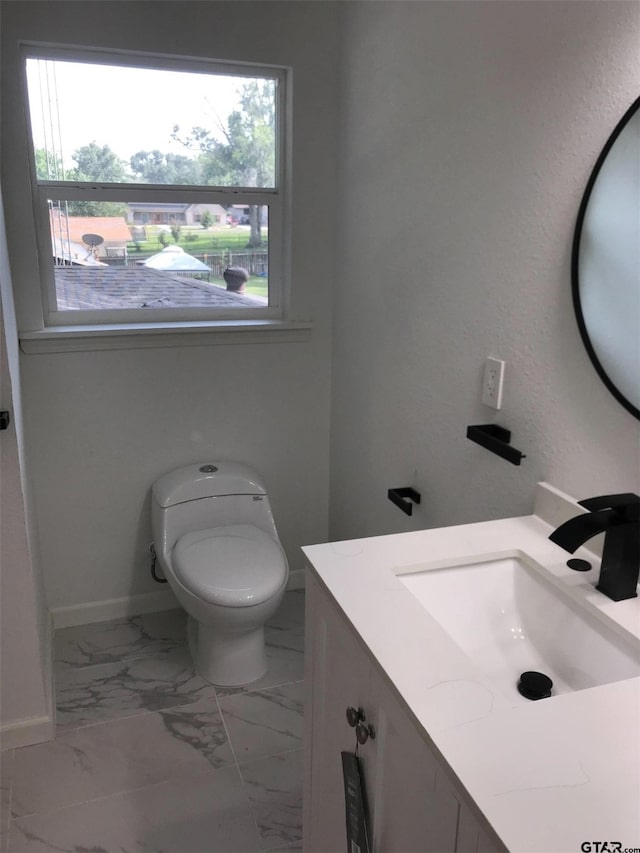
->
151, 462, 280, 555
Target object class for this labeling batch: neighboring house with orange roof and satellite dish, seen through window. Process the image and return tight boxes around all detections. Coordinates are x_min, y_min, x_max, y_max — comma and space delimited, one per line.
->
49, 209, 131, 262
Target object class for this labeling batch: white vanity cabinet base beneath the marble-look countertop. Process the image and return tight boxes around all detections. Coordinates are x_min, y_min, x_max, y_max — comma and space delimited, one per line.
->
304, 571, 505, 853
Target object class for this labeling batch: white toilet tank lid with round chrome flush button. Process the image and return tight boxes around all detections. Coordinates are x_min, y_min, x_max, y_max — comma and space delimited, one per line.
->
152, 462, 267, 507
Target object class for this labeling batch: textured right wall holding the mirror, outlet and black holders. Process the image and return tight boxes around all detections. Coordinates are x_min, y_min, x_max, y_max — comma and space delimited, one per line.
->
330, 0, 640, 538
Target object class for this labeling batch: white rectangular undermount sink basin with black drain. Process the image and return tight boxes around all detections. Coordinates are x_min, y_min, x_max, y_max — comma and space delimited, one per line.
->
395, 552, 640, 702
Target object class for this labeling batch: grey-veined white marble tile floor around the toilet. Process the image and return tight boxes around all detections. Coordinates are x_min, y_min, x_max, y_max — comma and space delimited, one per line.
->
0, 590, 304, 853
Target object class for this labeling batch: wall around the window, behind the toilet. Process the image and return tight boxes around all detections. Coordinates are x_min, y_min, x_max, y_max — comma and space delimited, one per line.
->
3, 2, 337, 608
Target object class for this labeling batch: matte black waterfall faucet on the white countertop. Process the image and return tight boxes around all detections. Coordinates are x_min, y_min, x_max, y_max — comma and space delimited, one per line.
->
549, 493, 640, 601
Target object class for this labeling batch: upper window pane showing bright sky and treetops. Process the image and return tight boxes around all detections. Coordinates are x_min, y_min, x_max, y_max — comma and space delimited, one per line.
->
27, 58, 276, 188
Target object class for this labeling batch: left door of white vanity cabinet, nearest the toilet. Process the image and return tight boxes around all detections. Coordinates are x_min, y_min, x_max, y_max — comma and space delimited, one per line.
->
303, 577, 376, 853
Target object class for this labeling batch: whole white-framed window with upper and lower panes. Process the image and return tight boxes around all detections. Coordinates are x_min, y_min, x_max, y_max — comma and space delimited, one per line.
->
25, 47, 286, 327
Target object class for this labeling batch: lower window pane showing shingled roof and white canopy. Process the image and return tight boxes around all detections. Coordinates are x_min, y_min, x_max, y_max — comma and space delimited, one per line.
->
49, 201, 269, 311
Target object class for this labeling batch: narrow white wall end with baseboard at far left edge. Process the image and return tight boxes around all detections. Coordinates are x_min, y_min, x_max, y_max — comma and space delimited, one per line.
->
0, 188, 53, 749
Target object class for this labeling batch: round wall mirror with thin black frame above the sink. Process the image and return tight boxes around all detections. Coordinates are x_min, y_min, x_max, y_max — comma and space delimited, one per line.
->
571, 98, 640, 419
